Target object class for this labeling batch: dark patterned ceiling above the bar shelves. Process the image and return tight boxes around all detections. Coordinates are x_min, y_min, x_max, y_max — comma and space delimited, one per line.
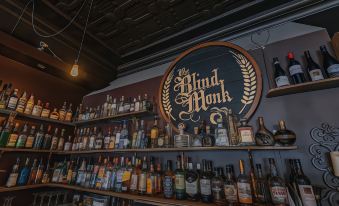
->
0, 0, 334, 89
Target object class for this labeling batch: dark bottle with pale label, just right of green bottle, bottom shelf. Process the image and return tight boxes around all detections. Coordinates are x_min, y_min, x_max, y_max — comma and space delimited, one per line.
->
185, 160, 200, 201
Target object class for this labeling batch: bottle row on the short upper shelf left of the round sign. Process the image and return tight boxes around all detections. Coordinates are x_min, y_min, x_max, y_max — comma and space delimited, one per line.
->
75, 94, 154, 121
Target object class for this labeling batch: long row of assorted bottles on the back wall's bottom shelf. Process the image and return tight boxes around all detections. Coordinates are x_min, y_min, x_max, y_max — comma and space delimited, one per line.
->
6, 154, 317, 206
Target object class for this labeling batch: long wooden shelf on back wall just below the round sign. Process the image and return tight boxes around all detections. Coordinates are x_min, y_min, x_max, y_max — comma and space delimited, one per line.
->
53, 146, 297, 155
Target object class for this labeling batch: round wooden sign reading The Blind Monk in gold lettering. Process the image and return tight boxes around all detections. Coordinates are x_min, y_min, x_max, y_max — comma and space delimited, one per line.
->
159, 42, 262, 132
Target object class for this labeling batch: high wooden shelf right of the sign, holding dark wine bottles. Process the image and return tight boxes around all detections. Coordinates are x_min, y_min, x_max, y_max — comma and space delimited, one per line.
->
266, 77, 339, 98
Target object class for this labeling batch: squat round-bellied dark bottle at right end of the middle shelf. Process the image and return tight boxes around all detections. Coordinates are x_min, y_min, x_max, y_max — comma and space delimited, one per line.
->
274, 120, 297, 146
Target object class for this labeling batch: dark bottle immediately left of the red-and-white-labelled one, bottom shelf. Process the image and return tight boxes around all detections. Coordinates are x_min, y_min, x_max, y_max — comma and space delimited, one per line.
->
256, 164, 270, 203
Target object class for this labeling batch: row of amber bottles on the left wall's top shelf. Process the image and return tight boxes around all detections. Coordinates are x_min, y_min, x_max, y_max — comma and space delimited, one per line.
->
0, 80, 73, 122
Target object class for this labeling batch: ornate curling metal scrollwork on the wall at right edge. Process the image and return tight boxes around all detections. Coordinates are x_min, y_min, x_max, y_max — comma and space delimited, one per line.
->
309, 123, 339, 205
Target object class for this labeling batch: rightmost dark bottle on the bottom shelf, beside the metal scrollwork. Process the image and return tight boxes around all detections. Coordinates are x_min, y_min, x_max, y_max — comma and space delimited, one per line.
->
295, 159, 317, 206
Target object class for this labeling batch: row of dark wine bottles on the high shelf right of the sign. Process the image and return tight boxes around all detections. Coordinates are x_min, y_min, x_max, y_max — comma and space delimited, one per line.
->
273, 46, 339, 87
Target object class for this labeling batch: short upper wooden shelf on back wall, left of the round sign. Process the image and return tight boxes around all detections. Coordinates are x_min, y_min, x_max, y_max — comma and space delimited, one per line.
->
74, 111, 152, 125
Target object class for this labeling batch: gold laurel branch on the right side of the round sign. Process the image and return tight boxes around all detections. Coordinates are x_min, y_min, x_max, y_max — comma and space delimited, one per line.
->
231, 51, 257, 114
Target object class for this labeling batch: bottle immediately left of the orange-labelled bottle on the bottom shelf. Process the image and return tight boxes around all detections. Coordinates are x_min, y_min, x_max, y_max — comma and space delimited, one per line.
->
224, 165, 238, 205
